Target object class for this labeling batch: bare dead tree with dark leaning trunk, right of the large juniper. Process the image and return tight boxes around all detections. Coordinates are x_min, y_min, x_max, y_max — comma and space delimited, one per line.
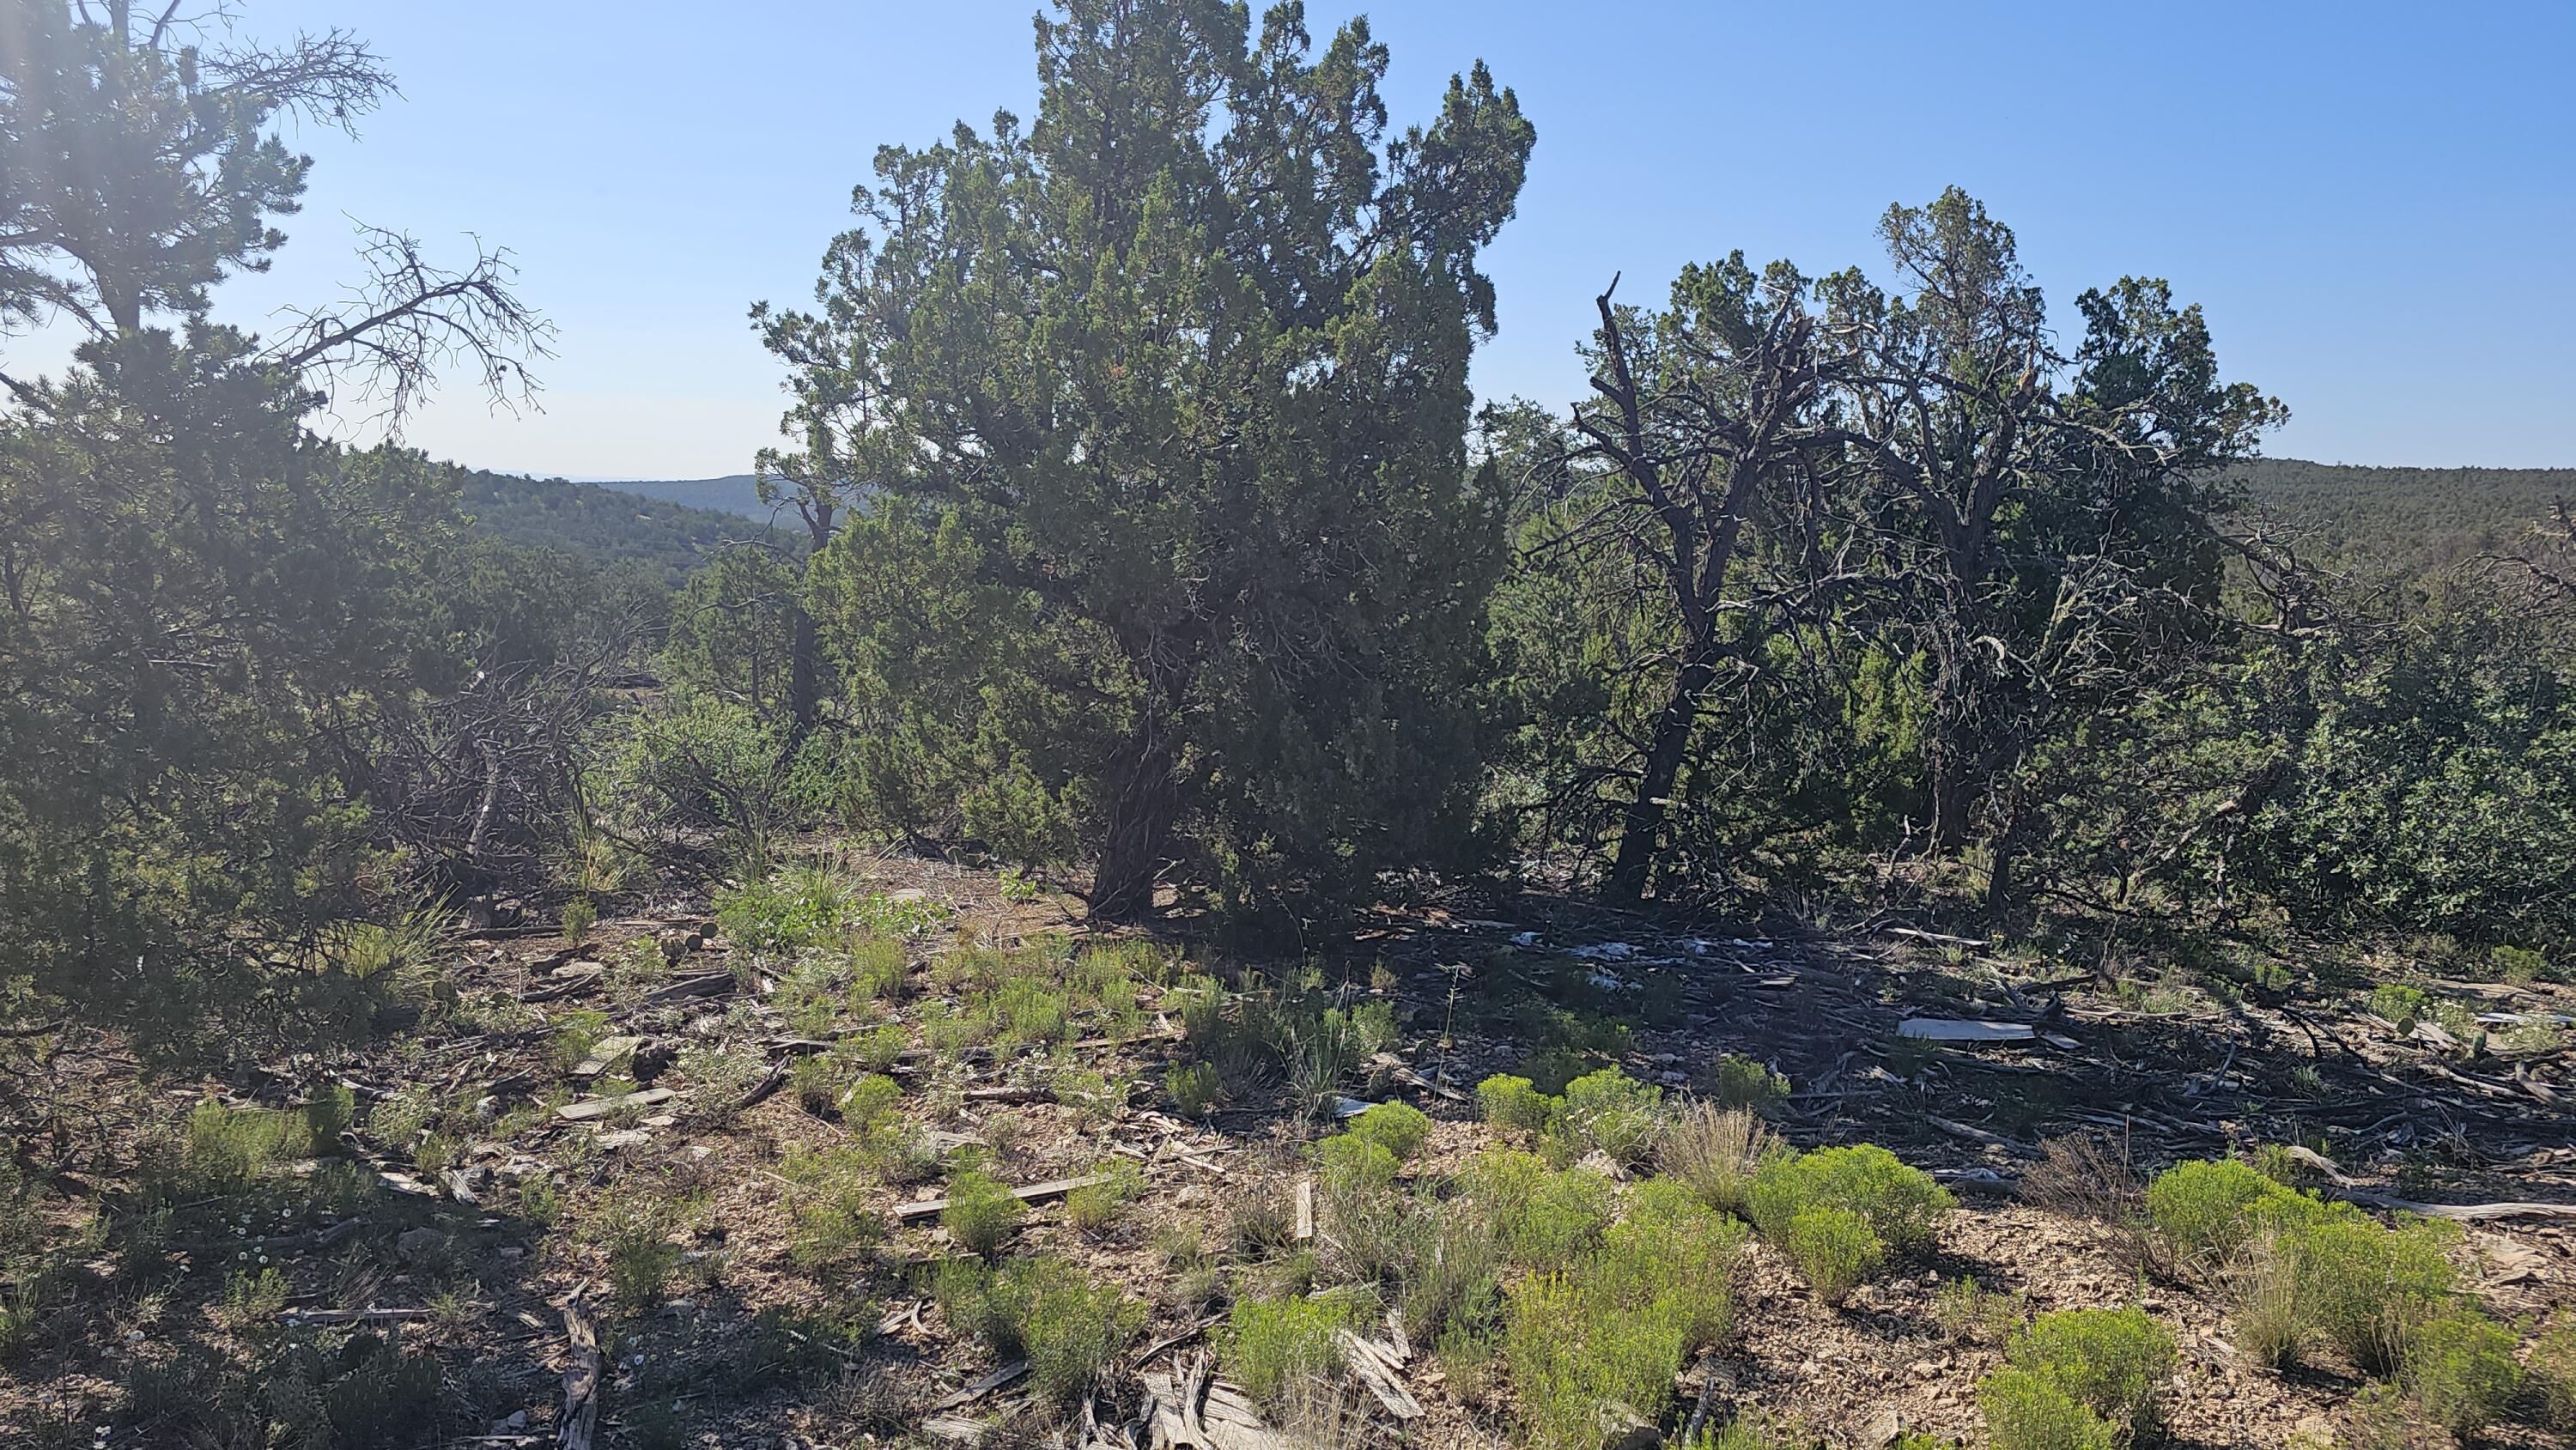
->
1574, 252, 1826, 901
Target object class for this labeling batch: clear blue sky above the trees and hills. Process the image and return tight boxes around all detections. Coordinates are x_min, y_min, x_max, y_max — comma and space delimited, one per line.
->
20, 0, 2576, 476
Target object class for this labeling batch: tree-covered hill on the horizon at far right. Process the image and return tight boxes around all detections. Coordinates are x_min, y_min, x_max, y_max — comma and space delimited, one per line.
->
2241, 458, 2576, 579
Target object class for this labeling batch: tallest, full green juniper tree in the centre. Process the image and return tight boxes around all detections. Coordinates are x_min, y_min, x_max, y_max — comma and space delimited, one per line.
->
757, 0, 1533, 917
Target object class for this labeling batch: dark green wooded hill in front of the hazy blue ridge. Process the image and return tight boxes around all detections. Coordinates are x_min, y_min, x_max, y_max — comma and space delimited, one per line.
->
451, 466, 788, 582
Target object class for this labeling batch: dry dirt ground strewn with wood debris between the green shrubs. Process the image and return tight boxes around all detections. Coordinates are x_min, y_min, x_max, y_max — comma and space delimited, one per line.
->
0, 858, 2576, 1450
